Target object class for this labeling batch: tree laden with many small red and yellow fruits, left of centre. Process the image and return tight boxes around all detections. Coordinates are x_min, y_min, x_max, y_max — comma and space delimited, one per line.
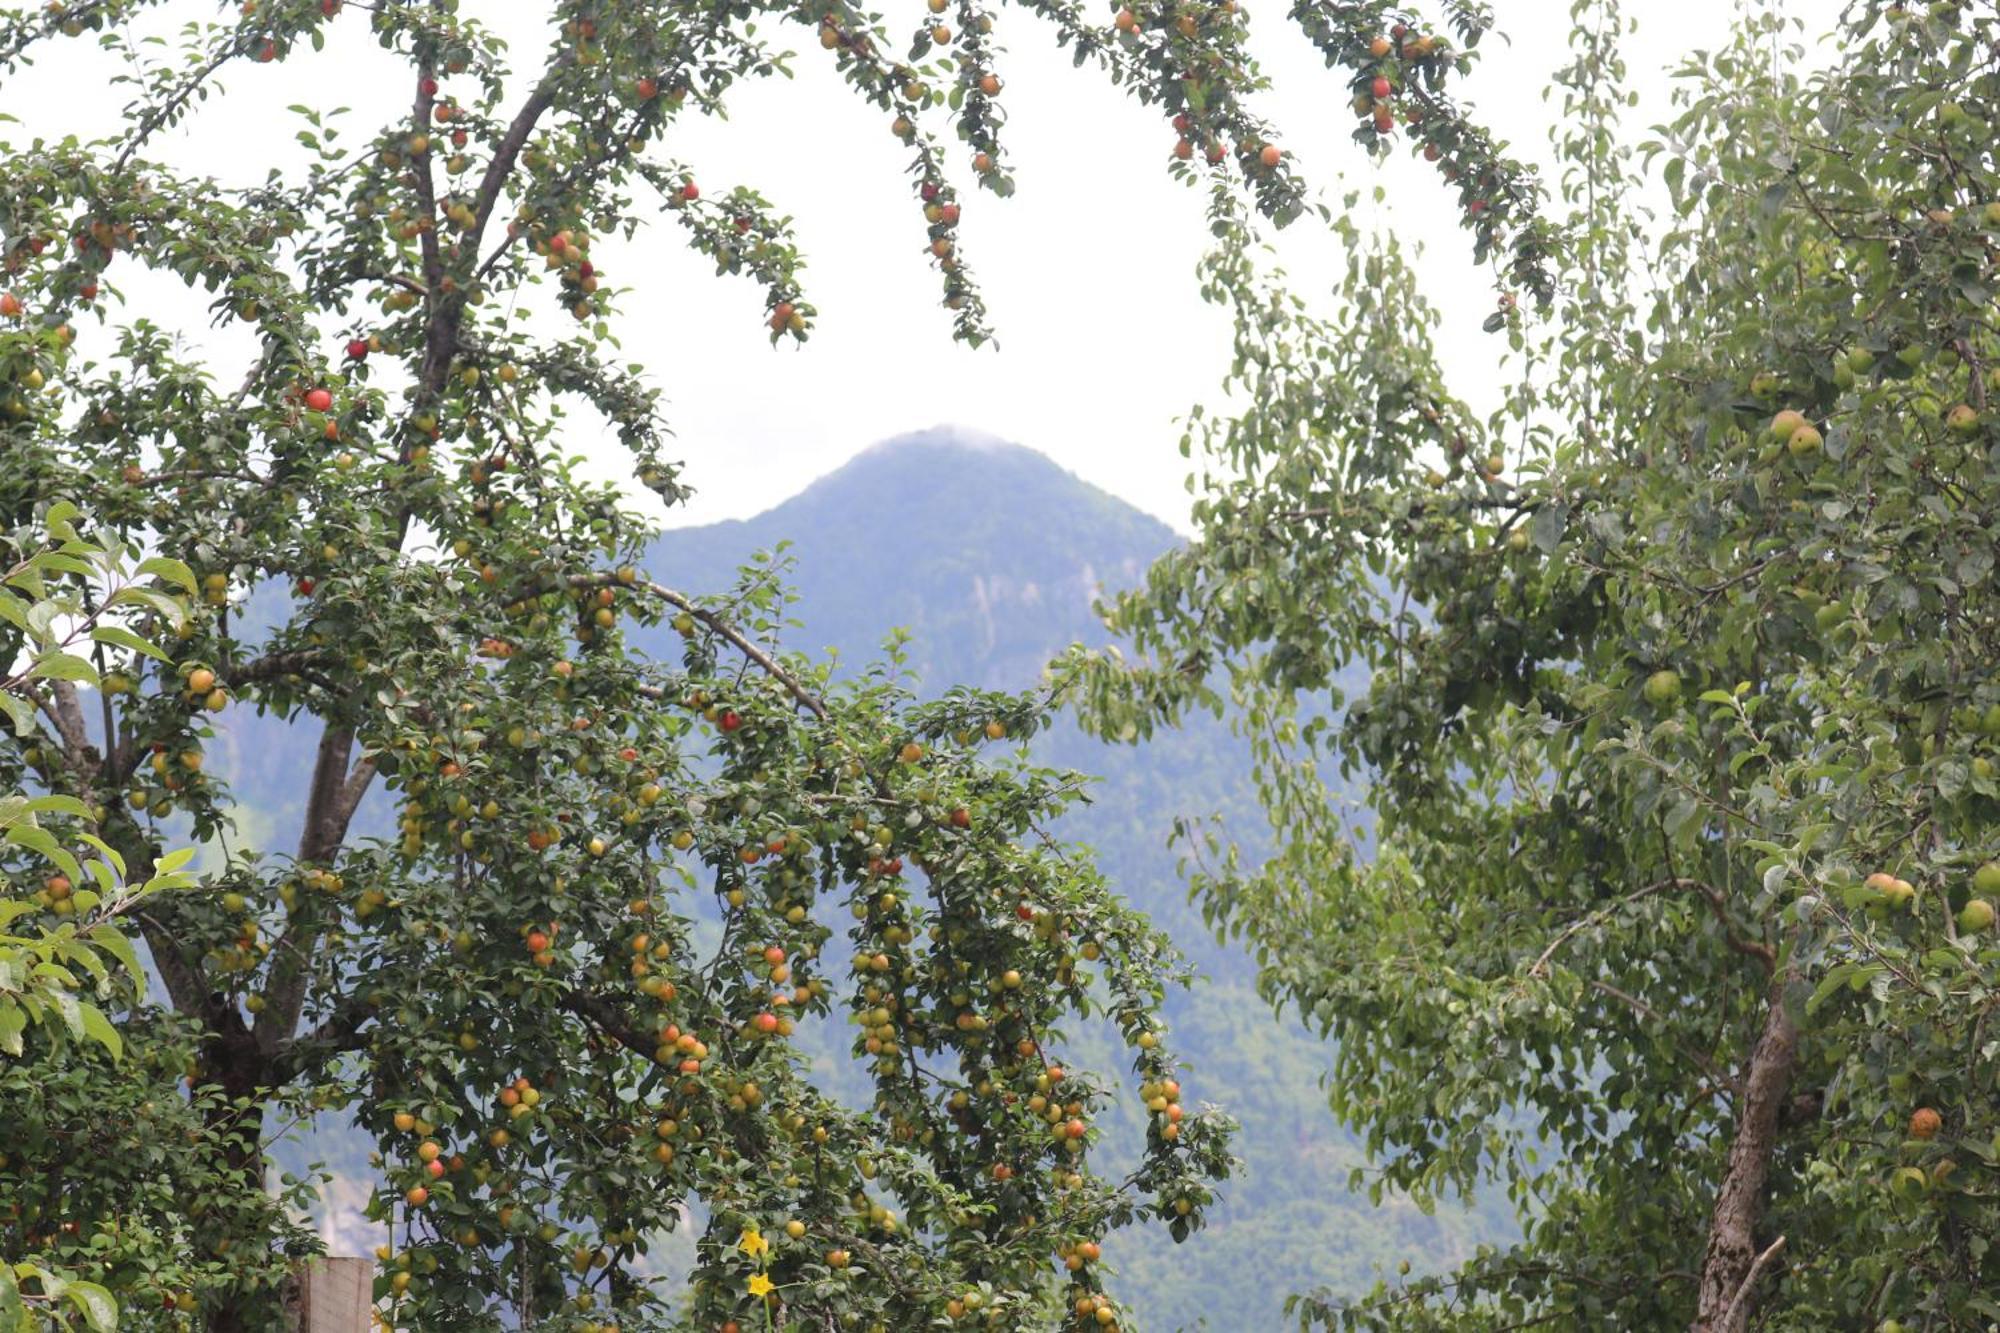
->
0, 0, 1548, 1331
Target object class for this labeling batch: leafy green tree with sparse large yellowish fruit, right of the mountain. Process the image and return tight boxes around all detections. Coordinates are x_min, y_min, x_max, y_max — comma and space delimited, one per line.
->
1070, 0, 2000, 1331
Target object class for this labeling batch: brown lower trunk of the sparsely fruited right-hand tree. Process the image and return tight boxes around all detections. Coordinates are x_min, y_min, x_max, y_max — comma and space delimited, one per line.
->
1692, 971, 1798, 1333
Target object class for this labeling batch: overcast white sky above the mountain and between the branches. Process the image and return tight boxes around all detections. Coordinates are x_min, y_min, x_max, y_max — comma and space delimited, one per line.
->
0, 0, 1840, 526
